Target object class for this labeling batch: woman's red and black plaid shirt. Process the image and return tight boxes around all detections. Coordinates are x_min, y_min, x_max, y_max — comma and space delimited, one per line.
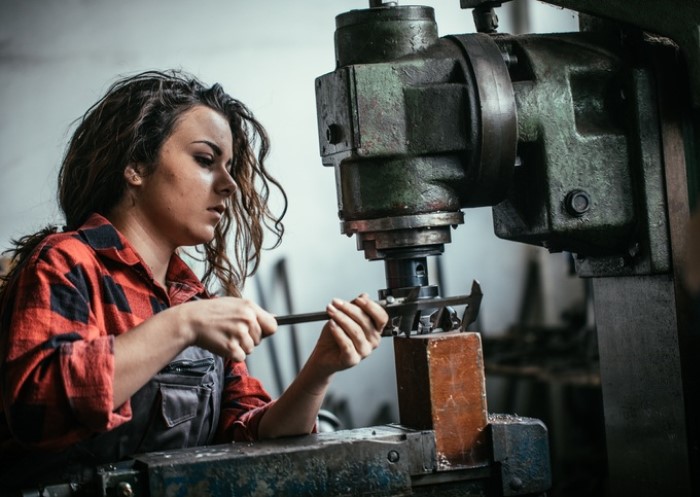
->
0, 214, 271, 460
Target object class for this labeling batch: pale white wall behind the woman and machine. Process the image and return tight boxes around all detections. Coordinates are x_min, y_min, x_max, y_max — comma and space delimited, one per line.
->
0, 0, 576, 425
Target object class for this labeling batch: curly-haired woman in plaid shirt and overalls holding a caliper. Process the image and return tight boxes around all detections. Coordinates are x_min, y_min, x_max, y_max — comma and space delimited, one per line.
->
0, 72, 388, 488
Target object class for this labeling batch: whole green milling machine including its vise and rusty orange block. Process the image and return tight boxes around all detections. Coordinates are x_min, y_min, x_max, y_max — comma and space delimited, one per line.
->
85, 0, 700, 497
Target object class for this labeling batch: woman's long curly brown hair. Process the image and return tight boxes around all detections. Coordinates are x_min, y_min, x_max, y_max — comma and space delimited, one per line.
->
3, 70, 287, 296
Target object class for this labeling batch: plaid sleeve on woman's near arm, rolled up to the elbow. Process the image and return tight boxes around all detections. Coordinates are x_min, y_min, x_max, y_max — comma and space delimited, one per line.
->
1, 242, 131, 448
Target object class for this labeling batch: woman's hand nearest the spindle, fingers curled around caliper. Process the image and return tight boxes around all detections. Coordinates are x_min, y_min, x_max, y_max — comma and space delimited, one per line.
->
309, 293, 389, 375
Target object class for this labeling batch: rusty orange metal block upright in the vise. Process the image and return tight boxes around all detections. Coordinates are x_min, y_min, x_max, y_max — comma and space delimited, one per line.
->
394, 332, 488, 469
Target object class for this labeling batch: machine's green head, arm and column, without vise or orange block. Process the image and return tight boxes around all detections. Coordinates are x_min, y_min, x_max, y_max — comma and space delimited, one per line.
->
316, 0, 700, 496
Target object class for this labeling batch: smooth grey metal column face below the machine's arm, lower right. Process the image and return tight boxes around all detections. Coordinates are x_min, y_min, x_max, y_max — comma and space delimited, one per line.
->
593, 275, 697, 497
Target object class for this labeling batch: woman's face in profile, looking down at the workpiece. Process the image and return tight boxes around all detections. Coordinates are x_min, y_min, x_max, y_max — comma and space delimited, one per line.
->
136, 106, 235, 250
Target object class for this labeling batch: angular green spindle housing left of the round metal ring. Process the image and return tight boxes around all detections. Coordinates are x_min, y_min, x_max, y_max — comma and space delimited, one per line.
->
317, 47, 478, 220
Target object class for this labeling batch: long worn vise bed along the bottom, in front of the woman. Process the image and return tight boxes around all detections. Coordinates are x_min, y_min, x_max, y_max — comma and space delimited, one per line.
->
137, 427, 434, 497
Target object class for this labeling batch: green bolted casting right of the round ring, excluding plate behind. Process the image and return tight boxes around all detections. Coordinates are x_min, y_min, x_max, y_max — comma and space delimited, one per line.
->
494, 34, 636, 270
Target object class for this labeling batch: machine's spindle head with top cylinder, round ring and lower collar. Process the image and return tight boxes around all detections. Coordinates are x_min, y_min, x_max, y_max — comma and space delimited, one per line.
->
316, 7, 516, 259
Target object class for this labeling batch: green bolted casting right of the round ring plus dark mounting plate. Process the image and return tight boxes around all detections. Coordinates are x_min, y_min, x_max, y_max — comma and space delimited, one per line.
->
486, 33, 670, 276
